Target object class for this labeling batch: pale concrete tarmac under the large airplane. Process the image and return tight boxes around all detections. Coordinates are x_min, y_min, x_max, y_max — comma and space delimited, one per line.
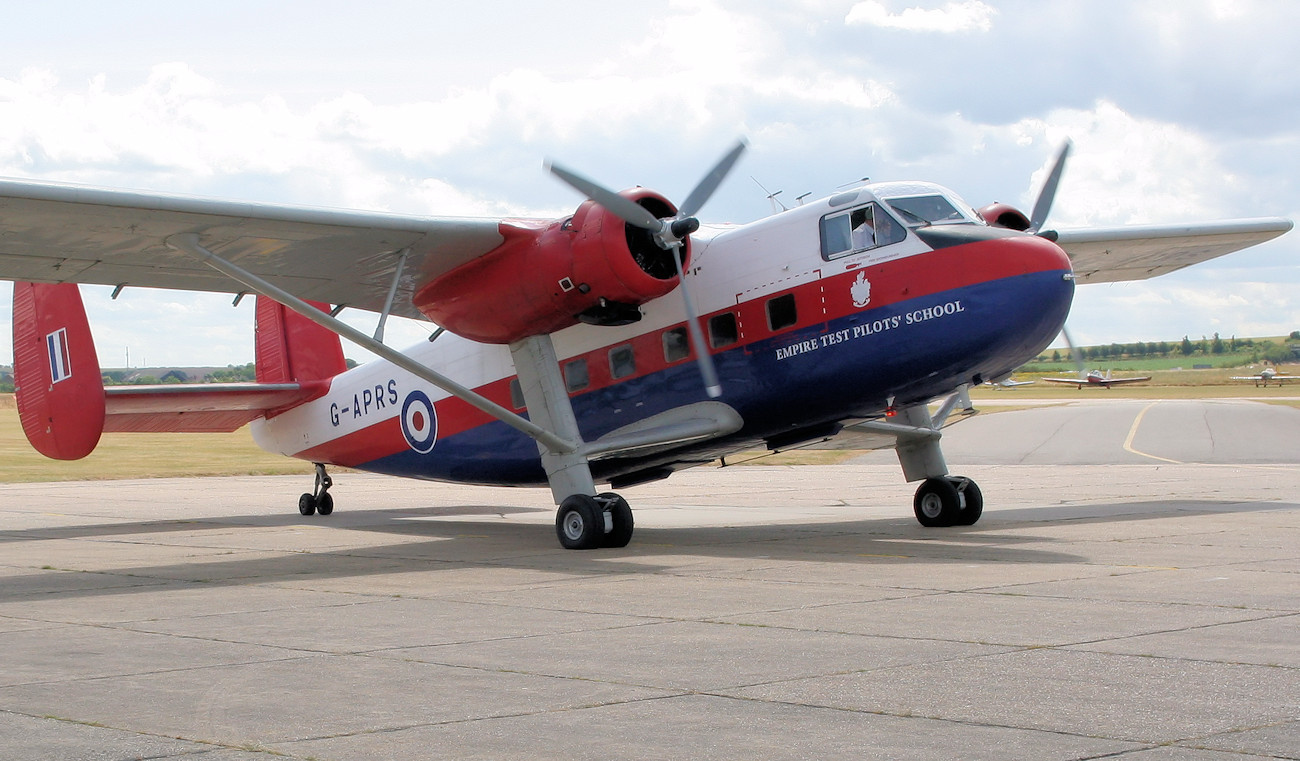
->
0, 393, 1300, 761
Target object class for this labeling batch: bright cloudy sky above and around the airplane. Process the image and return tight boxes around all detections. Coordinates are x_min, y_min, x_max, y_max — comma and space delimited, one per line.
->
0, 0, 1300, 367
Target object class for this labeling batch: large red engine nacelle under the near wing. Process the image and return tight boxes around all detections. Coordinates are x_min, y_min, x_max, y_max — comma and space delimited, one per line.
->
415, 187, 690, 343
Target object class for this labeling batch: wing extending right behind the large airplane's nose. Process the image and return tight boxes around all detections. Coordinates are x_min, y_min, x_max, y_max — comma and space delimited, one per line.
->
1044, 217, 1291, 284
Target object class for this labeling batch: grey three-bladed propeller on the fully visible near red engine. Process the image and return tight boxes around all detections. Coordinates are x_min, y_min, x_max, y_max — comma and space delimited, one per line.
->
546, 140, 746, 398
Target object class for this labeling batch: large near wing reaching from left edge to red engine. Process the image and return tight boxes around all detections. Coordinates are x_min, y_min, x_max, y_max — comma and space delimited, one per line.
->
0, 180, 503, 319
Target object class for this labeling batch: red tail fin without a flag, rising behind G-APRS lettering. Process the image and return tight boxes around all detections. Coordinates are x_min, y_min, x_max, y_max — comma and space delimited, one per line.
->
256, 297, 347, 384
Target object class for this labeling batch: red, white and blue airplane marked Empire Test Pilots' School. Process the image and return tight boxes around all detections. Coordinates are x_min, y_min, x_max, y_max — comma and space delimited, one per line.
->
0, 143, 1291, 549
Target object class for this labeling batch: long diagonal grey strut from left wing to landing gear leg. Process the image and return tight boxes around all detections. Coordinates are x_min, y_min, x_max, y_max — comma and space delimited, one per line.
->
166, 233, 581, 454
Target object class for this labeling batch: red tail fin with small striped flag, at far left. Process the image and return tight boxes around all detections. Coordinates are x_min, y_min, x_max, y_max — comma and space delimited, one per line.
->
13, 282, 104, 459
